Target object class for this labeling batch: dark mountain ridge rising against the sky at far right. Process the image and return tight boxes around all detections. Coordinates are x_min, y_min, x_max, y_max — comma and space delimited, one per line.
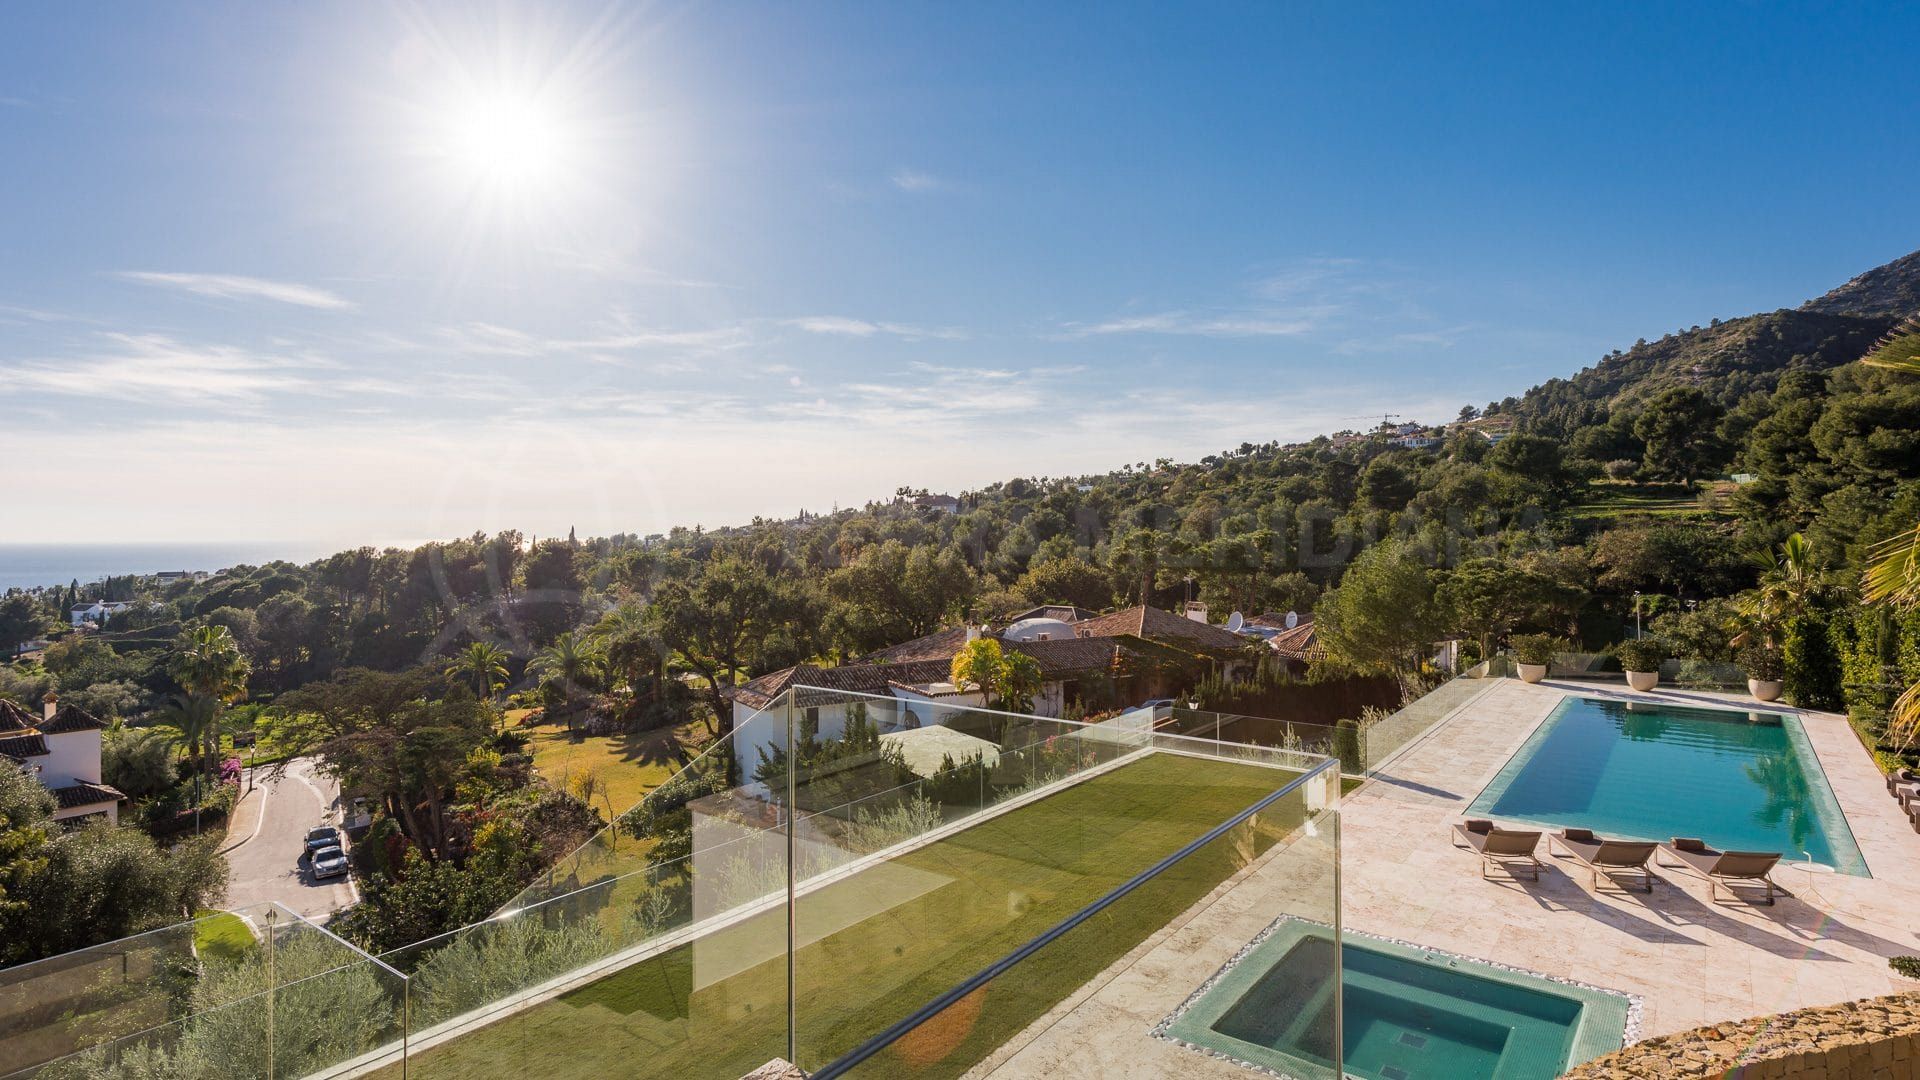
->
1488, 244, 1920, 434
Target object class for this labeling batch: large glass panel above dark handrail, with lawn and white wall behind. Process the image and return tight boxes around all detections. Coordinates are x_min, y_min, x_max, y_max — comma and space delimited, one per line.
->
795, 690, 1332, 1068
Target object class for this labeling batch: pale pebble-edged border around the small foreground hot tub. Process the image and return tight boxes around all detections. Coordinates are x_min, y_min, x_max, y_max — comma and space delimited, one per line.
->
1148, 915, 1645, 1080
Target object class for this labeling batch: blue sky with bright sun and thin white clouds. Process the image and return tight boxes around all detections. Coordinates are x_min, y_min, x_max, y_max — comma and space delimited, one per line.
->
0, 4, 1920, 542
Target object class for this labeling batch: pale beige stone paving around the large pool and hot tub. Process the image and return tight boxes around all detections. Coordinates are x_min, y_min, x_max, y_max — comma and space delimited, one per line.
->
975, 680, 1920, 1078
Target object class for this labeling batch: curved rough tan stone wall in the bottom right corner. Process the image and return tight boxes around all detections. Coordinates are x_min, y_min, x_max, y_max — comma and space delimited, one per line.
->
1567, 992, 1920, 1080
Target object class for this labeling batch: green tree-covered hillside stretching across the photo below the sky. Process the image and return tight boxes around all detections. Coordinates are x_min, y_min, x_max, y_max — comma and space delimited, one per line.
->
0, 245, 1920, 957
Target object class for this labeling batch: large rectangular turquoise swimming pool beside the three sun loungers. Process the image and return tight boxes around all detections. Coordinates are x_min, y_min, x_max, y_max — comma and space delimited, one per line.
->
1467, 698, 1868, 876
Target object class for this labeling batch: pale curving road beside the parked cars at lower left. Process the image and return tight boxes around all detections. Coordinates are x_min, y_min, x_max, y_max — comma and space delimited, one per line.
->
227, 757, 359, 920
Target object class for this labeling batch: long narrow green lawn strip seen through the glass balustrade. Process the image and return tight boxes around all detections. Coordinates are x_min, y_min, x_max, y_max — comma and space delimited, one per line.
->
390, 753, 1302, 1080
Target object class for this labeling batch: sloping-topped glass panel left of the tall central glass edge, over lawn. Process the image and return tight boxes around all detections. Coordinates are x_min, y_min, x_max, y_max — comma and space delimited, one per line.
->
382, 698, 789, 1080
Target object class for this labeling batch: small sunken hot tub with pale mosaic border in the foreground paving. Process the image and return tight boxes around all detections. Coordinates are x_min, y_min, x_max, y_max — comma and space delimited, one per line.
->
1156, 919, 1632, 1080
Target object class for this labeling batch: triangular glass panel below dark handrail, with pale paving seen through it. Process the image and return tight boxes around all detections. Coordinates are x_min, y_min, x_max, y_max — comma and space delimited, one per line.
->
821, 753, 1338, 1080
